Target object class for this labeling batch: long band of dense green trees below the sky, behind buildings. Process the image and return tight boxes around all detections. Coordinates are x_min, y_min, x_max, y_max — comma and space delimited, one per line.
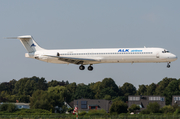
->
0, 76, 180, 111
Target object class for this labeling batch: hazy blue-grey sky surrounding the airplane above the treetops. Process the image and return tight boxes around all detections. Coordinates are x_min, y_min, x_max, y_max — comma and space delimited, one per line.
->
0, 0, 180, 88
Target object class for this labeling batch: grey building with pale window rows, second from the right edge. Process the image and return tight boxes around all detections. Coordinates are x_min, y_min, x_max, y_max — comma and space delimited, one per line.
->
128, 96, 166, 111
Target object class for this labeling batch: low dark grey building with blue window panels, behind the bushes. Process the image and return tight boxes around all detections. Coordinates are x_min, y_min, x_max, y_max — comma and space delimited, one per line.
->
73, 99, 112, 112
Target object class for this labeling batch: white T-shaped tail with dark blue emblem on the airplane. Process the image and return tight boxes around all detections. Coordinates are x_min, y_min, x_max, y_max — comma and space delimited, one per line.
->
6, 35, 44, 53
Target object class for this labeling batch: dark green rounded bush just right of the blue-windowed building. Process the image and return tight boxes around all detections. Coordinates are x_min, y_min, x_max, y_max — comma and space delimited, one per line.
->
110, 101, 128, 114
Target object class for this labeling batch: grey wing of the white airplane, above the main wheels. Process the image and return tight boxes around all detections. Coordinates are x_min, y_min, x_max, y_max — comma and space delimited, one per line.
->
44, 55, 101, 64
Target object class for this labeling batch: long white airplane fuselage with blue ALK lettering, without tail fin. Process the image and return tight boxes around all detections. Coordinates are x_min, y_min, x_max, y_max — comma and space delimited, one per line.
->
26, 48, 177, 65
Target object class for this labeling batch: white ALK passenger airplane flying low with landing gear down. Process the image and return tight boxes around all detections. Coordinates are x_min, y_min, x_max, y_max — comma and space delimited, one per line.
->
6, 35, 177, 71
